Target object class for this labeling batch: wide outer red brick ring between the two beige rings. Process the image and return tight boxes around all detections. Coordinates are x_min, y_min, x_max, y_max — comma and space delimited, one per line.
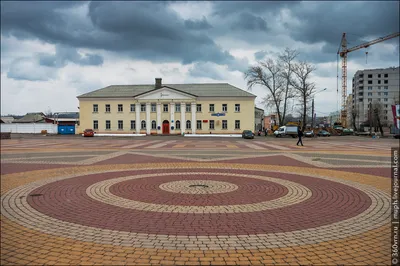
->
28, 169, 371, 235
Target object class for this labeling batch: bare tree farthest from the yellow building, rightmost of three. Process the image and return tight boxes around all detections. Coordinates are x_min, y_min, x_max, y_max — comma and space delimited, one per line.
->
291, 61, 315, 130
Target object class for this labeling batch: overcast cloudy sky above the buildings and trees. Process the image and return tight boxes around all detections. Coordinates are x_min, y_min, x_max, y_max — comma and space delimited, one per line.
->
1, 1, 399, 116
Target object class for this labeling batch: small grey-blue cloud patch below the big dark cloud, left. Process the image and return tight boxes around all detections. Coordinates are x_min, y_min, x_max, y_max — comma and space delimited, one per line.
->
38, 45, 103, 68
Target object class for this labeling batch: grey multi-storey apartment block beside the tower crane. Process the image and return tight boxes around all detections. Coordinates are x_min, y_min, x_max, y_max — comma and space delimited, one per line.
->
350, 67, 400, 128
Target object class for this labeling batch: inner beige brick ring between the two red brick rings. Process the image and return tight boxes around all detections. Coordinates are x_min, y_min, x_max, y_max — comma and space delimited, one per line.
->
86, 172, 312, 213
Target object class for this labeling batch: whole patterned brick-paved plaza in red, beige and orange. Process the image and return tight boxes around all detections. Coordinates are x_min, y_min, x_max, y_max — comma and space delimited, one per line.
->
1, 136, 398, 265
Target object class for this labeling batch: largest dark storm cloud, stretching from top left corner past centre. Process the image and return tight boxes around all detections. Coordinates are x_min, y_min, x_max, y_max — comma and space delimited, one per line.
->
1, 2, 244, 70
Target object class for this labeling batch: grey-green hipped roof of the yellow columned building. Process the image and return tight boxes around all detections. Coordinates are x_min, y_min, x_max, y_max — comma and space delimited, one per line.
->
78, 83, 256, 98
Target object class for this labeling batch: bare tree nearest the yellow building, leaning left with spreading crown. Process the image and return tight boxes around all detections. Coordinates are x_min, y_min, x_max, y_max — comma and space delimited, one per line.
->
245, 59, 284, 125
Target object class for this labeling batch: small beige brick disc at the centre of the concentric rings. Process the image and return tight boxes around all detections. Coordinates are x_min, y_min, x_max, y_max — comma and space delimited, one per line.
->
158, 179, 239, 194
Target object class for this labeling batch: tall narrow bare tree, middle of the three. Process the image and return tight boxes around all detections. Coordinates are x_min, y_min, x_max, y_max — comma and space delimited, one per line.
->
279, 48, 299, 125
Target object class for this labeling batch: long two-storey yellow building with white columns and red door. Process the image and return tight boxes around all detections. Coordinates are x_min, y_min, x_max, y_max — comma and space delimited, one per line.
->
77, 78, 256, 135
